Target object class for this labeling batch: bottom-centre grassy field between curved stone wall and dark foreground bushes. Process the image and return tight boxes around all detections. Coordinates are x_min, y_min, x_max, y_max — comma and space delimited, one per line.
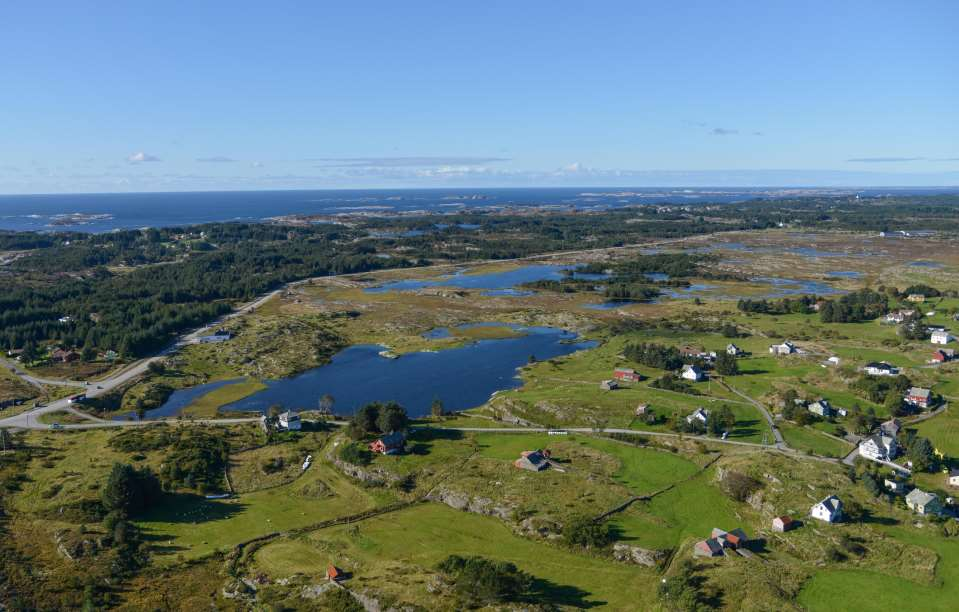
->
256, 504, 659, 610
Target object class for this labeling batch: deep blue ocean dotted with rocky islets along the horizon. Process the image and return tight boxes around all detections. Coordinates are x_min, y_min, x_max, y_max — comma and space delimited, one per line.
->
0, 188, 956, 232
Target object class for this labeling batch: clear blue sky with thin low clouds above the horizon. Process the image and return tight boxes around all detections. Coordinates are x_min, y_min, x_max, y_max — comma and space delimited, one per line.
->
0, 0, 959, 193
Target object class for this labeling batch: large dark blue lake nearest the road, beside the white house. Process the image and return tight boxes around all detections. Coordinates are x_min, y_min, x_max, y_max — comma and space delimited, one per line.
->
149, 327, 597, 417
